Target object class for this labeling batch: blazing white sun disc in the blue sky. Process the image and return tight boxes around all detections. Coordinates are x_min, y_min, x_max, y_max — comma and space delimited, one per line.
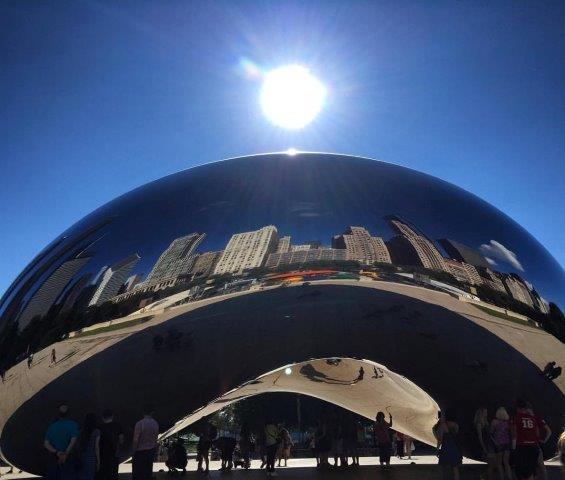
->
261, 65, 326, 129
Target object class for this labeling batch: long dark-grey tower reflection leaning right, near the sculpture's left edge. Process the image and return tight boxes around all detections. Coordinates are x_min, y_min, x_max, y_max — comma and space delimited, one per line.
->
19, 257, 90, 329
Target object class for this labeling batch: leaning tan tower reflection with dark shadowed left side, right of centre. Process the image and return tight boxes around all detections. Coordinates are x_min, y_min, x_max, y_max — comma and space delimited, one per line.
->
385, 215, 451, 273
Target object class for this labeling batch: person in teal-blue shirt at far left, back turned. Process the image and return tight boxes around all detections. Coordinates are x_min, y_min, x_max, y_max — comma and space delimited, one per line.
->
43, 404, 79, 480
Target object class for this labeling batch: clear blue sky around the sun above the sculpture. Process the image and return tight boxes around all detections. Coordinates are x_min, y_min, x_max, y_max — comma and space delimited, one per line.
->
0, 0, 565, 292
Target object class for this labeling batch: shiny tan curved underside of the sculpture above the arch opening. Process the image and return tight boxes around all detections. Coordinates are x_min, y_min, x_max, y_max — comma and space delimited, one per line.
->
162, 358, 439, 445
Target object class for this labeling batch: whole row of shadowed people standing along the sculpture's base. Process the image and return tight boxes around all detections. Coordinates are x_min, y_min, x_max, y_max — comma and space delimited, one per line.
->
36, 399, 565, 480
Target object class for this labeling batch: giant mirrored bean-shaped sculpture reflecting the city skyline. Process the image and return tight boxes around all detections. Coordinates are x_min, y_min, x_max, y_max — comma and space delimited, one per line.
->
0, 153, 565, 474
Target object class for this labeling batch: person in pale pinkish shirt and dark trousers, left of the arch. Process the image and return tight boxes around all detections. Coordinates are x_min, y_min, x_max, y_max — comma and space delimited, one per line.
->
132, 406, 159, 480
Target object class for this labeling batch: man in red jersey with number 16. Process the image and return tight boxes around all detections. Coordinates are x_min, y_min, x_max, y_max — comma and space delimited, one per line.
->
510, 400, 551, 480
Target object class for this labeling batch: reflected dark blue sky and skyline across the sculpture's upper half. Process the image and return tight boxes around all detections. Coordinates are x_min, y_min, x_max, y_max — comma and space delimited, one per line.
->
0, 154, 563, 368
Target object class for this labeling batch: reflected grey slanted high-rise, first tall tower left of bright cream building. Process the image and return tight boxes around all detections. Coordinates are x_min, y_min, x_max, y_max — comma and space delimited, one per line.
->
145, 233, 206, 285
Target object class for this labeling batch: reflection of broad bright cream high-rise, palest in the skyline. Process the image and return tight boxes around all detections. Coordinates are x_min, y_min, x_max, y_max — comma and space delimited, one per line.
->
214, 225, 278, 275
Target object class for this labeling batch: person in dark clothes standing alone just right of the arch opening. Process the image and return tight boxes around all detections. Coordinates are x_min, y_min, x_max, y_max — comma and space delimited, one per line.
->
433, 410, 463, 480
